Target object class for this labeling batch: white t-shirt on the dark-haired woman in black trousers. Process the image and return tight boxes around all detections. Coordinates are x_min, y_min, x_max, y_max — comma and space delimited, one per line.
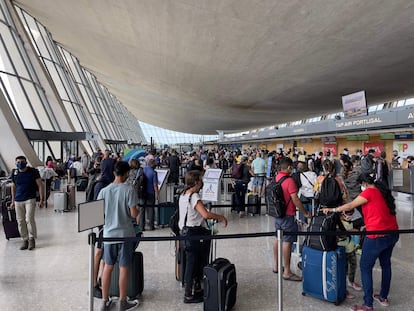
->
178, 193, 206, 229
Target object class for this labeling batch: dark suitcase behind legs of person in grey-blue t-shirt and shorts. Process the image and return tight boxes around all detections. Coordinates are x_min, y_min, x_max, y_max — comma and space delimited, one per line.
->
109, 252, 144, 299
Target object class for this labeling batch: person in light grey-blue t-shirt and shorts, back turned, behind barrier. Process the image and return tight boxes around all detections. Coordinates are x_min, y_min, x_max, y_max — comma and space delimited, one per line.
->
97, 161, 139, 311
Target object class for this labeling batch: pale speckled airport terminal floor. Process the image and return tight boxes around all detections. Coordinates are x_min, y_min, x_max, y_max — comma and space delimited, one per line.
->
0, 192, 414, 311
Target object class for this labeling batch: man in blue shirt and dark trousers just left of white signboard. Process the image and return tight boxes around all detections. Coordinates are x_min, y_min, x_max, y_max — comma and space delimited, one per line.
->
139, 159, 160, 231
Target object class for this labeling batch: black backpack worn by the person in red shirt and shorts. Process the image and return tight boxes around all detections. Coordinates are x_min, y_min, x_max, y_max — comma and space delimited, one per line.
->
265, 176, 291, 218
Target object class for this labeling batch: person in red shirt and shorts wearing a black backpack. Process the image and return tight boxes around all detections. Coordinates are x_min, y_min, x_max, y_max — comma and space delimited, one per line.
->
273, 157, 312, 281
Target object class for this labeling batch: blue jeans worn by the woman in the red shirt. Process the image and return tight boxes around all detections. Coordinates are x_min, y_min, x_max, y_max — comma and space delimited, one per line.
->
359, 234, 399, 307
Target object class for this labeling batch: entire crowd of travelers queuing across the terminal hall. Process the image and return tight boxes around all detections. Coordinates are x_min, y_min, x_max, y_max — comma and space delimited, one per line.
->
6, 148, 414, 311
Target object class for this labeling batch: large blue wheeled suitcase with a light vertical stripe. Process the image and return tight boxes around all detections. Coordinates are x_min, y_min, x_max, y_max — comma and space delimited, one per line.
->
302, 246, 346, 305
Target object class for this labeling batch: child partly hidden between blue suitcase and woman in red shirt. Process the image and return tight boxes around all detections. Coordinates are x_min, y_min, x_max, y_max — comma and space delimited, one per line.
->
338, 210, 362, 298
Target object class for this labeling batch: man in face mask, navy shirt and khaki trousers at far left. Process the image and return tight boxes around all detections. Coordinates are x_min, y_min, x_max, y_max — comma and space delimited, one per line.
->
10, 156, 44, 250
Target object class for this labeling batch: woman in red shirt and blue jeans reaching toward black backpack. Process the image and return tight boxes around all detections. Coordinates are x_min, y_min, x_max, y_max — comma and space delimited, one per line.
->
323, 173, 398, 311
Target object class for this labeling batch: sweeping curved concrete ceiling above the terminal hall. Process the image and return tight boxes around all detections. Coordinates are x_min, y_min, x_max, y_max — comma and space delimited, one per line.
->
14, 0, 414, 134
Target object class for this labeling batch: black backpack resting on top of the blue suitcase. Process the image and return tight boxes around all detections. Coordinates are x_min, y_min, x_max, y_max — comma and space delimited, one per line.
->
303, 213, 346, 252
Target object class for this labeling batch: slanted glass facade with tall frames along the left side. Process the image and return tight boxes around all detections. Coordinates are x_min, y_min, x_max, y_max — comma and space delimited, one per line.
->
0, 0, 147, 165
